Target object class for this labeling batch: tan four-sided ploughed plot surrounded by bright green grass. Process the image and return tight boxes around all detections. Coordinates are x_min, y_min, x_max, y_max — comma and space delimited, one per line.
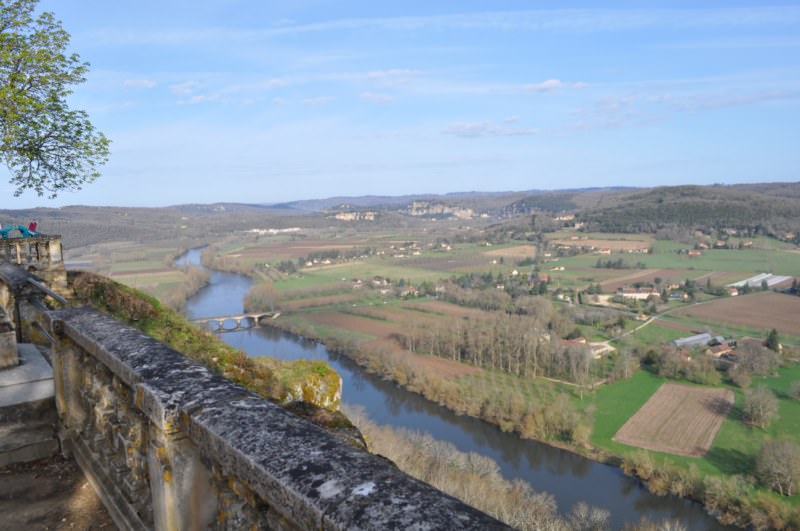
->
614, 383, 734, 457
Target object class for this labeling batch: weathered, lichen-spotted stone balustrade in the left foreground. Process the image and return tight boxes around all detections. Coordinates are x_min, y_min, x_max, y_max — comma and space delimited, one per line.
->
0, 236, 507, 530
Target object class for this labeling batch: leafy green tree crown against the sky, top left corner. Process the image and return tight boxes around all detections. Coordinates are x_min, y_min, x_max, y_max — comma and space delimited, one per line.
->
0, 0, 109, 198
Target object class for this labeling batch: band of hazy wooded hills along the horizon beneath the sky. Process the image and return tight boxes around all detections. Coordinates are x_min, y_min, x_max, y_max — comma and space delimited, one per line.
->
0, 183, 800, 247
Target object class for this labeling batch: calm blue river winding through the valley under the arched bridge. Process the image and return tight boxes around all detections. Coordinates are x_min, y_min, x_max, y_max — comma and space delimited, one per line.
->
176, 249, 729, 531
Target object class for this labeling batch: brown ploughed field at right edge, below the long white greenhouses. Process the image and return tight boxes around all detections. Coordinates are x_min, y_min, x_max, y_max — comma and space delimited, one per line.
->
673, 292, 800, 336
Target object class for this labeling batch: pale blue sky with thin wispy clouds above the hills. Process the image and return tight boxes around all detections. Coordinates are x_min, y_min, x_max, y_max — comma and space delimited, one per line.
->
0, 0, 800, 208
